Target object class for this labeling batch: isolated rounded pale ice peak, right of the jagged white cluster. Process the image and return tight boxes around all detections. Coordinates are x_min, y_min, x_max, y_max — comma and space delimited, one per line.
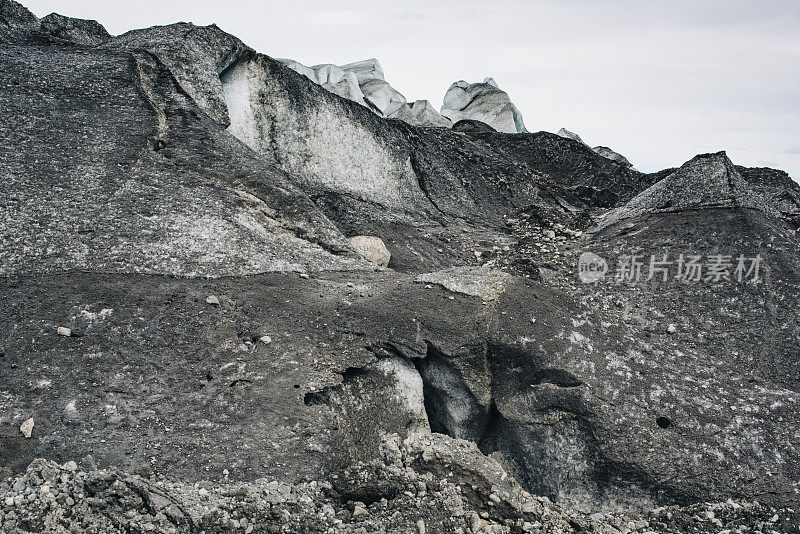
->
442, 78, 527, 133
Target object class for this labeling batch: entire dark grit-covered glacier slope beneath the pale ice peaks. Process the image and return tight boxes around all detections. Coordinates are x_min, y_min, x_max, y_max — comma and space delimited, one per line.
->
0, 0, 800, 532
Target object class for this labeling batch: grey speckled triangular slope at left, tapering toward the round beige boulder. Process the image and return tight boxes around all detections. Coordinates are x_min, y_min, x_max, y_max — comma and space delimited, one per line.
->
0, 27, 359, 276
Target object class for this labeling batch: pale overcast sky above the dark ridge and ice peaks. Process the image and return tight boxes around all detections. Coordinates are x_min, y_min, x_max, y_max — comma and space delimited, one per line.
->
22, 0, 800, 180
